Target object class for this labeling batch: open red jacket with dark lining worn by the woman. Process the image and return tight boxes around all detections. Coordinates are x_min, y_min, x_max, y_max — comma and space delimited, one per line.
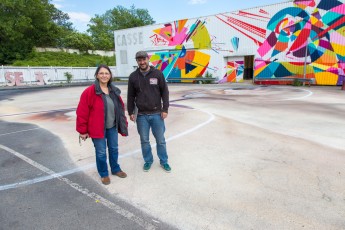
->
76, 83, 128, 138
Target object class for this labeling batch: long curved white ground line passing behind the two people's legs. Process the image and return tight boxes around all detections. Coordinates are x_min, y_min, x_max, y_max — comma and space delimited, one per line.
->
0, 110, 214, 191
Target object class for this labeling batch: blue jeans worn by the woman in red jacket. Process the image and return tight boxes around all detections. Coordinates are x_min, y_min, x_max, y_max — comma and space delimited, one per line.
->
92, 126, 121, 177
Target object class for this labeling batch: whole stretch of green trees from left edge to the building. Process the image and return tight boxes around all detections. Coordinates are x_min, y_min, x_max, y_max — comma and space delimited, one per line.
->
0, 0, 155, 65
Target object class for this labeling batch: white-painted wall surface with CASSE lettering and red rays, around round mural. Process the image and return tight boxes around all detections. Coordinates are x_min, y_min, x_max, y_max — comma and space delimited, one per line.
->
114, 2, 292, 79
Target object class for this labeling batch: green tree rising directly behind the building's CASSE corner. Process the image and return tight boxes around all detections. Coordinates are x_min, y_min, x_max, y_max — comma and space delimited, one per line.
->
87, 5, 155, 50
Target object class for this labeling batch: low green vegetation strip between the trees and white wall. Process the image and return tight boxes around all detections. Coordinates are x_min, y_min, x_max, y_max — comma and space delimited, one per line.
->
12, 52, 115, 67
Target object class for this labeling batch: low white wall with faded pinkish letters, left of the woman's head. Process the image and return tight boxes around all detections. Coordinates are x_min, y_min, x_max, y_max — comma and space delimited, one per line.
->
0, 66, 117, 87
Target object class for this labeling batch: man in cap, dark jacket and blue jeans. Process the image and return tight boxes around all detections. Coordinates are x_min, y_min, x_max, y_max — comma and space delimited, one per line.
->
127, 51, 171, 172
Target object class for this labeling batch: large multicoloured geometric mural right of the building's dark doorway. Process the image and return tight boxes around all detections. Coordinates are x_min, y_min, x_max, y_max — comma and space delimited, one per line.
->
254, 0, 345, 85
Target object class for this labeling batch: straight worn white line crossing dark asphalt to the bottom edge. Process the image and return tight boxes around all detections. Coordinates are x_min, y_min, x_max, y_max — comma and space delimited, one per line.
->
0, 144, 156, 230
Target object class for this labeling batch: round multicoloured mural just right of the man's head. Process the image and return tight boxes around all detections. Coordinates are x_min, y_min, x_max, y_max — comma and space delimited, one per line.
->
150, 20, 211, 78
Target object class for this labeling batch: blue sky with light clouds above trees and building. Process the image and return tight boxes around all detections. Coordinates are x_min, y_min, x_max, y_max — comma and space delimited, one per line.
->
51, 0, 289, 32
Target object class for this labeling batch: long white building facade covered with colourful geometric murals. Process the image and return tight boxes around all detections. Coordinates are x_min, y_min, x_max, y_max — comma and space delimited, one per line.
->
114, 0, 345, 85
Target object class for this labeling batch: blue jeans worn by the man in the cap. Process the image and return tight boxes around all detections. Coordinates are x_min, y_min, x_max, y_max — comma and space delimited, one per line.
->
137, 114, 168, 164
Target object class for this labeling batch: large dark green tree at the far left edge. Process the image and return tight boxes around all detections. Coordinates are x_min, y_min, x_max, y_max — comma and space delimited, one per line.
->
0, 0, 72, 64
